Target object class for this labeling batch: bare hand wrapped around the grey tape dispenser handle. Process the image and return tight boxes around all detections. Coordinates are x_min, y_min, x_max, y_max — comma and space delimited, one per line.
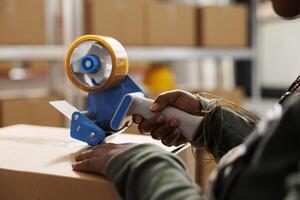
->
132, 90, 201, 146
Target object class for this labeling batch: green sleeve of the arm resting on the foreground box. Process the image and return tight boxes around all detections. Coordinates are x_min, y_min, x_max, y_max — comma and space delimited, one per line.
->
107, 144, 204, 200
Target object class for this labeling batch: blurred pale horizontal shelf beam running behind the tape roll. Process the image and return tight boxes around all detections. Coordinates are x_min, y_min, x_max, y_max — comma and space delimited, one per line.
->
0, 45, 254, 61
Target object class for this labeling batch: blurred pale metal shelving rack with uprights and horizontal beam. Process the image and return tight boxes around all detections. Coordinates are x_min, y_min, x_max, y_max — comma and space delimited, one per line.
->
0, 0, 260, 106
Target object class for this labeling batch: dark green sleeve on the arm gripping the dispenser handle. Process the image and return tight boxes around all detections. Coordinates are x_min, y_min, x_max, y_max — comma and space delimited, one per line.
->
191, 95, 258, 161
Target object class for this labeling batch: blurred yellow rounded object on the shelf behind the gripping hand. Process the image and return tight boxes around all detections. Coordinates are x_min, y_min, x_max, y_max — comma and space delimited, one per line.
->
144, 64, 176, 92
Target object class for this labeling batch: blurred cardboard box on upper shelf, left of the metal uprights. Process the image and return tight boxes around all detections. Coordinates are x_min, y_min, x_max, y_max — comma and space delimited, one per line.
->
0, 0, 45, 44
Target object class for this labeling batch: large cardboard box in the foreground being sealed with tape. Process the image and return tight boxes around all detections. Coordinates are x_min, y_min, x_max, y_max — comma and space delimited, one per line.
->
0, 125, 195, 200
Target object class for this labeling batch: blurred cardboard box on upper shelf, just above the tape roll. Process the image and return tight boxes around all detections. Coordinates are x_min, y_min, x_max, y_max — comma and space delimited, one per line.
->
86, 0, 144, 45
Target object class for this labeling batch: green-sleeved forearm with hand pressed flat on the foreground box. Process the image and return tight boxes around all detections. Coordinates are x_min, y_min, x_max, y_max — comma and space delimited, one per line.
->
73, 143, 203, 200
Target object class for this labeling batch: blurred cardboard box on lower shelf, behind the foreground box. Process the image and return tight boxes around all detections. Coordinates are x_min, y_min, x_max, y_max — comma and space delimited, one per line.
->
0, 96, 64, 127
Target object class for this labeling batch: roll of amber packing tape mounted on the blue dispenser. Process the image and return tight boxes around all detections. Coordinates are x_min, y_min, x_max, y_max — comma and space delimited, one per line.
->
65, 35, 128, 92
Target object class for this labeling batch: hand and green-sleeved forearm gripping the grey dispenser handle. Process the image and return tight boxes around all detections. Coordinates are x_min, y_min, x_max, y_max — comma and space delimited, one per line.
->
133, 90, 257, 160
